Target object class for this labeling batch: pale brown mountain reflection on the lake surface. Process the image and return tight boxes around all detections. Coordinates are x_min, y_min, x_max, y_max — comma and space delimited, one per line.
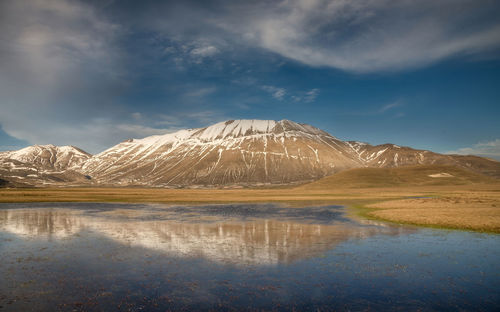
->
0, 204, 409, 264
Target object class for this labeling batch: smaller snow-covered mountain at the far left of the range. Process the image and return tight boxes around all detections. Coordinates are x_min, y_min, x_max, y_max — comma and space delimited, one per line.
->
0, 145, 92, 185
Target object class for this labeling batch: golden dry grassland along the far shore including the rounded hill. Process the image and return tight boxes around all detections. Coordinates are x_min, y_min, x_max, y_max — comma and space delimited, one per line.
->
0, 166, 500, 233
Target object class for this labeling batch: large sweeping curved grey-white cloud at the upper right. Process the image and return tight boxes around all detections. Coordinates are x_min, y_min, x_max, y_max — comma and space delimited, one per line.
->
251, 0, 500, 72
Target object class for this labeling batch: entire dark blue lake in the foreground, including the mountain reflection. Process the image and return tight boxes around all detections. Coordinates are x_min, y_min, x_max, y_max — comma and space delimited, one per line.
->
0, 203, 500, 311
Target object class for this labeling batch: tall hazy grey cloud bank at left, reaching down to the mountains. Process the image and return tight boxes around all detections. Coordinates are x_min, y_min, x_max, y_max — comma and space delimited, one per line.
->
0, 0, 131, 151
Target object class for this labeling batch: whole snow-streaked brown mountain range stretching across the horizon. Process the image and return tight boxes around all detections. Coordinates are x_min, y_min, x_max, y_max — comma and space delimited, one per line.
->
0, 120, 500, 187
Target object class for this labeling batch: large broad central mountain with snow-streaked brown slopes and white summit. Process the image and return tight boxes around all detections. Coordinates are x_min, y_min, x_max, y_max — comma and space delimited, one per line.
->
82, 120, 362, 186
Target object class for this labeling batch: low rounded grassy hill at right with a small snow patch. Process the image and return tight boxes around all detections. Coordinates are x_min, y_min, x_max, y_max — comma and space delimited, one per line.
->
299, 165, 499, 189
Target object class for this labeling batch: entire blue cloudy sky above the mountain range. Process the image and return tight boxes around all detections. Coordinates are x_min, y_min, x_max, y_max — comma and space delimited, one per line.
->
0, 0, 500, 159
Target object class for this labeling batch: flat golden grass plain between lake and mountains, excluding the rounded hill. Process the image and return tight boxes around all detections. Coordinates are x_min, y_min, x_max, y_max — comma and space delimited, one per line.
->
0, 184, 500, 233
